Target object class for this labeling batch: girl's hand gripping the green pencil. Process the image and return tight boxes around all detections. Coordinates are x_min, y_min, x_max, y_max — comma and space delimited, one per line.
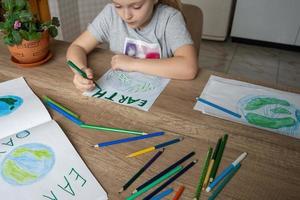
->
73, 68, 95, 92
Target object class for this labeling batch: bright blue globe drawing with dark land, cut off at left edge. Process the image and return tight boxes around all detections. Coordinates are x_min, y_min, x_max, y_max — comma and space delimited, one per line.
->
0, 95, 23, 117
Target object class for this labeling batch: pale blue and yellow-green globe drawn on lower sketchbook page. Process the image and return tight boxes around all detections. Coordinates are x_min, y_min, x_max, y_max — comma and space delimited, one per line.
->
1, 143, 55, 185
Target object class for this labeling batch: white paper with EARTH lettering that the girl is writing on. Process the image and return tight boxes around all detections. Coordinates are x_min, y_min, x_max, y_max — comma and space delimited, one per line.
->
84, 69, 169, 111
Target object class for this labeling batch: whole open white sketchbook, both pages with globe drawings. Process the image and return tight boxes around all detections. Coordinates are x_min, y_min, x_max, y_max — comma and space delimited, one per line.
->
0, 78, 107, 200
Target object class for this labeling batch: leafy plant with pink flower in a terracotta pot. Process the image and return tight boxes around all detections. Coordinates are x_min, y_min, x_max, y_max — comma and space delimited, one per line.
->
0, 0, 60, 64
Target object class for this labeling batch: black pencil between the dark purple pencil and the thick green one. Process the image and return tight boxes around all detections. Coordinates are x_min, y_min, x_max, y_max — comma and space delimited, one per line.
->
132, 151, 195, 193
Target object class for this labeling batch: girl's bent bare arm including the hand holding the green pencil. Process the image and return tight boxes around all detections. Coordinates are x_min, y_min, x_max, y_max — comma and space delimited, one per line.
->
67, 31, 99, 91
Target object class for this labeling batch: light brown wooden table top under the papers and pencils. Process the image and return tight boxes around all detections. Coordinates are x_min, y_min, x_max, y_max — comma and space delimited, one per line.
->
0, 41, 300, 200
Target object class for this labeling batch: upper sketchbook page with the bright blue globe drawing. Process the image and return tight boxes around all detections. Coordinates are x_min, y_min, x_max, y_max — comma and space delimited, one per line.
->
0, 78, 51, 138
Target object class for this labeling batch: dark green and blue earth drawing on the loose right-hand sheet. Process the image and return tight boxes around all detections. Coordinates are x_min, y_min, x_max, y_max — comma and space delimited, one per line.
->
238, 96, 300, 137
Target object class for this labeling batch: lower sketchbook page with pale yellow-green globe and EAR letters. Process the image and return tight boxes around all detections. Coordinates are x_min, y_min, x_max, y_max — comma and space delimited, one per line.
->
0, 121, 107, 200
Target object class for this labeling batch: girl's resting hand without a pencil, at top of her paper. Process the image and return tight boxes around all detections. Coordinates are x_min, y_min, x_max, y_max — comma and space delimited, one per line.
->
111, 55, 135, 72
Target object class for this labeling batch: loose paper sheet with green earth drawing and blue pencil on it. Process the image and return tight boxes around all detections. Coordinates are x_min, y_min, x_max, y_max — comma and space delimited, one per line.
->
194, 76, 300, 138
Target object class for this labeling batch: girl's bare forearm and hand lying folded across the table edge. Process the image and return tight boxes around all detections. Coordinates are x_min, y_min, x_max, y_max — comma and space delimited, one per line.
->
111, 45, 198, 80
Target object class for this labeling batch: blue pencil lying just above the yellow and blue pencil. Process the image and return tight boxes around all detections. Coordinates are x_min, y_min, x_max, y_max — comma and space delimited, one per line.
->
94, 132, 165, 148
